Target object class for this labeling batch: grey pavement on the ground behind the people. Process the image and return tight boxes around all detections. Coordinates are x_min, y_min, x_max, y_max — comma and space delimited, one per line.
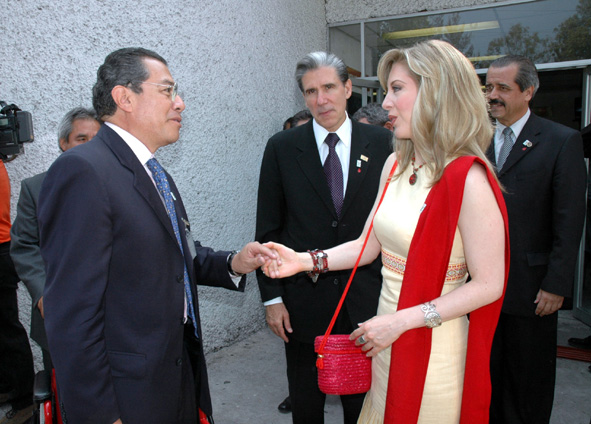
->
207, 311, 591, 424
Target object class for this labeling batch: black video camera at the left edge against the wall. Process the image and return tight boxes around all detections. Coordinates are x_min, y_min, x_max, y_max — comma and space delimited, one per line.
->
0, 100, 34, 161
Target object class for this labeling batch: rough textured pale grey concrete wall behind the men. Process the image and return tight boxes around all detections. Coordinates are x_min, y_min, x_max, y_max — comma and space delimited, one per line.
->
0, 0, 327, 368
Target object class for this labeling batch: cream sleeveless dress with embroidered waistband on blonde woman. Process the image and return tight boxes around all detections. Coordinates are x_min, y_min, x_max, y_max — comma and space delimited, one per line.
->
358, 166, 468, 424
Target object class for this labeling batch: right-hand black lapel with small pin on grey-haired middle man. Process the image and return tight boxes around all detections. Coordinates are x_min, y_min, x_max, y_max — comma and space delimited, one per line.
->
341, 121, 372, 216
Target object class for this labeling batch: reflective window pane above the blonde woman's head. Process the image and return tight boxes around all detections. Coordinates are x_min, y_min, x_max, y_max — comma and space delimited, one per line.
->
330, 0, 591, 76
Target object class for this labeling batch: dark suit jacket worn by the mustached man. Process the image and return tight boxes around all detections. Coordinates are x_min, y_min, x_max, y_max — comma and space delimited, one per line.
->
488, 113, 586, 316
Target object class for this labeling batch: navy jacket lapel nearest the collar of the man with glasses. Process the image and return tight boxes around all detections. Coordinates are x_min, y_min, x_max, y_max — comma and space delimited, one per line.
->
101, 125, 177, 243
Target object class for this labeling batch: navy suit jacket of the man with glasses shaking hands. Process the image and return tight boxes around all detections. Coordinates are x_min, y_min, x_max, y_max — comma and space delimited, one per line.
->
38, 125, 244, 424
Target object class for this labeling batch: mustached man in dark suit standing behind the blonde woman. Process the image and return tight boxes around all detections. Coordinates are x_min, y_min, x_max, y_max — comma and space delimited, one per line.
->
486, 56, 586, 424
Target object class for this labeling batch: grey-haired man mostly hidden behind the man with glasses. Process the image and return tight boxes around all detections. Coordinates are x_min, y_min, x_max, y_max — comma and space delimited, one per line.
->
10, 107, 100, 370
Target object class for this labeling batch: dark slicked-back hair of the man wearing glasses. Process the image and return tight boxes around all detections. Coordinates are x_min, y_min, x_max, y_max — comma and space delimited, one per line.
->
92, 47, 167, 119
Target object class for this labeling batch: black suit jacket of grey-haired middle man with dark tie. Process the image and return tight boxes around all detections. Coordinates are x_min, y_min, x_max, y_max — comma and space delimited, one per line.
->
256, 121, 392, 343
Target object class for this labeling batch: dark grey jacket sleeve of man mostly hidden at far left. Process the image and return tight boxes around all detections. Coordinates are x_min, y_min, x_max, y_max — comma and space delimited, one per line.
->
10, 172, 49, 350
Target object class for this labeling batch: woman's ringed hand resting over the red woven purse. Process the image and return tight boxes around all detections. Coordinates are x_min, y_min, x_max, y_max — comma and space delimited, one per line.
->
349, 312, 406, 357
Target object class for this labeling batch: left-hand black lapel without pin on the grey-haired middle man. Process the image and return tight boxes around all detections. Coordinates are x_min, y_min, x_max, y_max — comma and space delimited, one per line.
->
297, 120, 337, 218
